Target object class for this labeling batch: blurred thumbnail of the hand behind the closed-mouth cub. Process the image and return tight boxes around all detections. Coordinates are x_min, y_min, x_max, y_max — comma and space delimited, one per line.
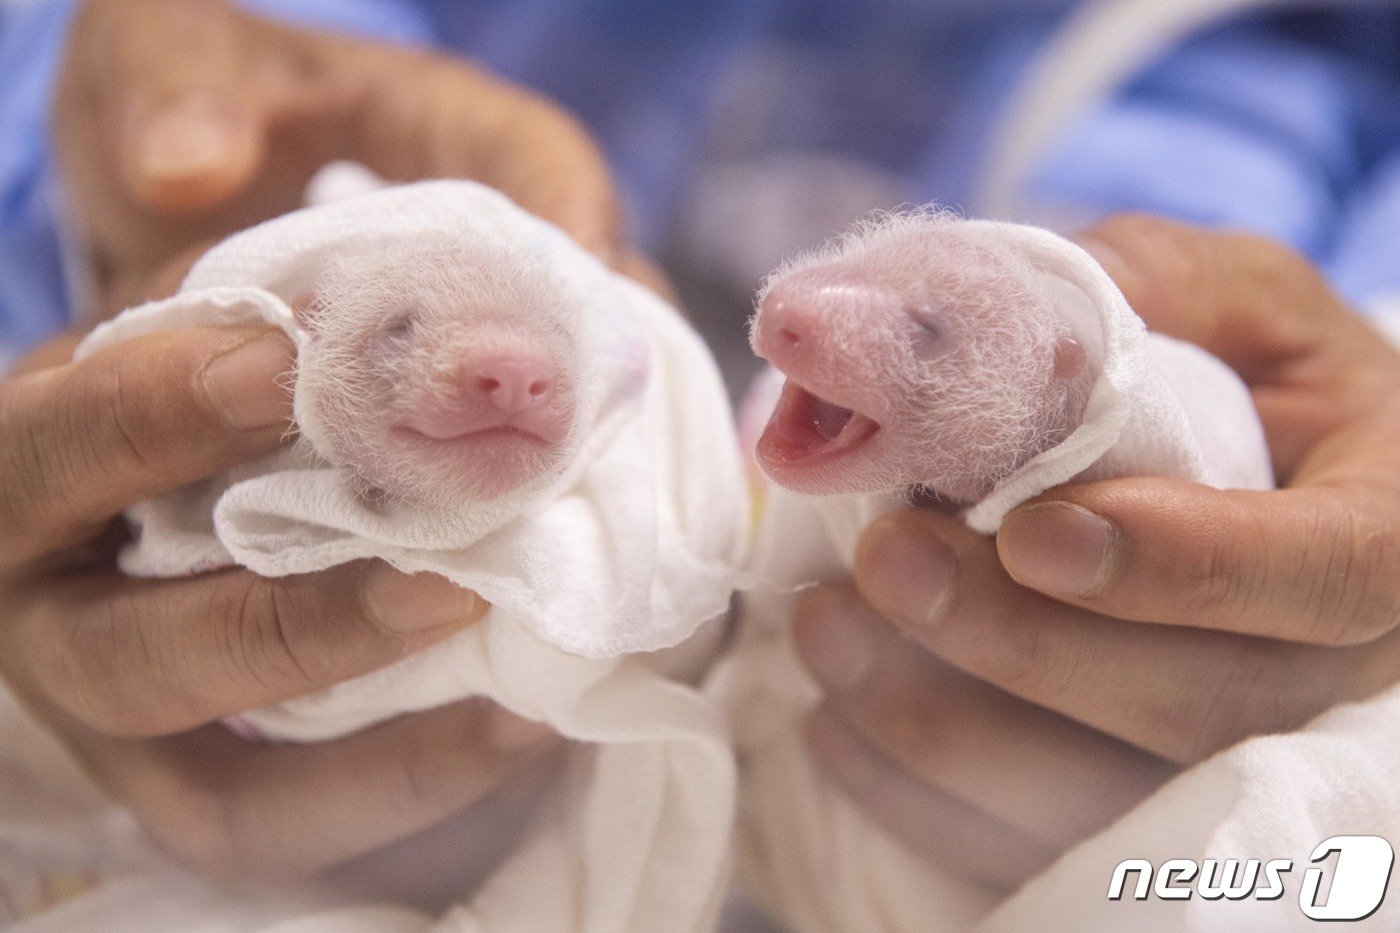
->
133, 95, 238, 179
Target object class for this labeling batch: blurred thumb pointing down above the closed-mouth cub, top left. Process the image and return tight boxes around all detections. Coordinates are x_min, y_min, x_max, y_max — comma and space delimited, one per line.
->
98, 0, 263, 213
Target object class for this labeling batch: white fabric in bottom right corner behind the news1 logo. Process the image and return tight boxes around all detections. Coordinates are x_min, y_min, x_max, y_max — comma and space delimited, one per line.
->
985, 688, 1400, 933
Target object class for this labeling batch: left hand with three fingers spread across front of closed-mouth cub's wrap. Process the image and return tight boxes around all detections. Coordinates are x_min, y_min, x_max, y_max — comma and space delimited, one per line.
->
0, 329, 557, 880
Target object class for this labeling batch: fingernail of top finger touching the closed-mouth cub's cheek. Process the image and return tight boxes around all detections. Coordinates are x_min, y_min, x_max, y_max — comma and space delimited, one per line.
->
204, 332, 295, 431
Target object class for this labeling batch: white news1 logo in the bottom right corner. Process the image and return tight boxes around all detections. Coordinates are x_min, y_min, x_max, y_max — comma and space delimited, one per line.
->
1109, 836, 1396, 920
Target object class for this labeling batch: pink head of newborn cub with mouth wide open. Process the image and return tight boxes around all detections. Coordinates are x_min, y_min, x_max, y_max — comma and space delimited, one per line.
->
752, 213, 1092, 504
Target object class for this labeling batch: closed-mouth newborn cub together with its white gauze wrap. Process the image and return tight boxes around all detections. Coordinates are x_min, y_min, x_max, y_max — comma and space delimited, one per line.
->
80, 181, 748, 930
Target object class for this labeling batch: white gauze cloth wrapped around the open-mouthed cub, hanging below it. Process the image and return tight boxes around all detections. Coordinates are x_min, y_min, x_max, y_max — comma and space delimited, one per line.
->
710, 221, 1273, 932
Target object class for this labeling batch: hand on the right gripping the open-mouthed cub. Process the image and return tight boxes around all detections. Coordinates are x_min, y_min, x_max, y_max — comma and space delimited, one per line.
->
795, 217, 1400, 890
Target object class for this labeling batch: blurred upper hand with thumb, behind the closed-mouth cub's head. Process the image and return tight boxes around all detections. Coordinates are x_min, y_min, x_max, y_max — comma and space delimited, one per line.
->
53, 0, 620, 314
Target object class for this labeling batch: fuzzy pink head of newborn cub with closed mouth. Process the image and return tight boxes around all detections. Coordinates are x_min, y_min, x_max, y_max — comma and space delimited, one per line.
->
293, 237, 582, 509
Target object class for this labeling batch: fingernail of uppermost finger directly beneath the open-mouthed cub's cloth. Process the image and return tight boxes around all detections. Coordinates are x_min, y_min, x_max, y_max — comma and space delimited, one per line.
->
997, 502, 1119, 597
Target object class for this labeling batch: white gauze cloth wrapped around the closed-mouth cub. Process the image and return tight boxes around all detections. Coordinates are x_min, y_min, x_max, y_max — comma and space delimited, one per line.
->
78, 181, 749, 930
